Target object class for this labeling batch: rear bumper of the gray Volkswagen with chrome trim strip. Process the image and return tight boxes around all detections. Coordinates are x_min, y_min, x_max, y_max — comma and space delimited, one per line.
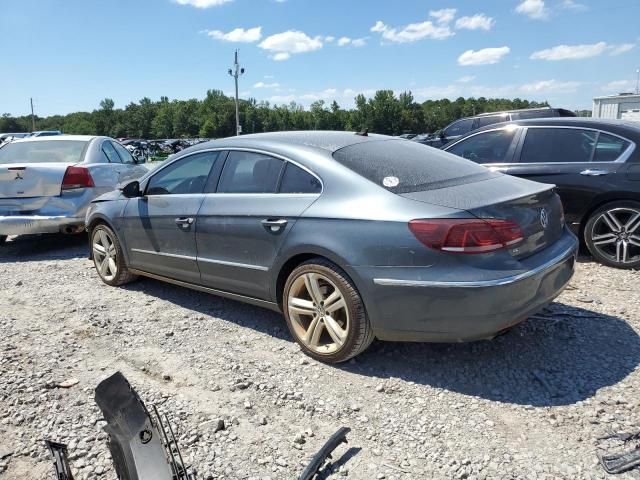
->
355, 229, 578, 342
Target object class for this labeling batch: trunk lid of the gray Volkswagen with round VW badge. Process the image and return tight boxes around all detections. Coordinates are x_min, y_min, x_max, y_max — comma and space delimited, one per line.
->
402, 175, 564, 259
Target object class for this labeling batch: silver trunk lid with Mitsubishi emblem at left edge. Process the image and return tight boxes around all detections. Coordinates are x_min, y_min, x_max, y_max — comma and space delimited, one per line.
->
0, 163, 71, 199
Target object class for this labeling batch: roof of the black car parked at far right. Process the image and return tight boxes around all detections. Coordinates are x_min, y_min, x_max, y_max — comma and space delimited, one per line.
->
469, 117, 640, 141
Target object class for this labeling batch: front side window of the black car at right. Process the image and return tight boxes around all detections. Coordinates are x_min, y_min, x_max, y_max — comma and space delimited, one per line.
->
447, 129, 516, 163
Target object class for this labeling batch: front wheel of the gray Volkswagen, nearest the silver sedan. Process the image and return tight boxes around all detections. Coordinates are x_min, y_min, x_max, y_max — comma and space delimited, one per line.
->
91, 224, 138, 287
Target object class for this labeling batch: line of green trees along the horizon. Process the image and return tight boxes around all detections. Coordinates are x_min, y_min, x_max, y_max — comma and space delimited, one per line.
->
0, 90, 548, 139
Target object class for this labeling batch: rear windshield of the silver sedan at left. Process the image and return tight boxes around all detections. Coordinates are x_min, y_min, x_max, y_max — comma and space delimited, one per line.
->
0, 140, 87, 164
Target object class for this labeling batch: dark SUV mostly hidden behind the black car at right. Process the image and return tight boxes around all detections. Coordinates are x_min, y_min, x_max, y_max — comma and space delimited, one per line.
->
414, 107, 576, 148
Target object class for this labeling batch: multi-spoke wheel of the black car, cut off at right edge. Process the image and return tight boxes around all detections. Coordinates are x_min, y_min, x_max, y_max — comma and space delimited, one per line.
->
584, 200, 640, 268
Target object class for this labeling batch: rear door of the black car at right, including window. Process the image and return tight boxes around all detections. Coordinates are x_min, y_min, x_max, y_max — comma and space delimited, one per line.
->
509, 127, 631, 228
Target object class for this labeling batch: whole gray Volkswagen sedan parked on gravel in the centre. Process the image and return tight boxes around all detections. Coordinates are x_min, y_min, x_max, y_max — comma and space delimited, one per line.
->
86, 132, 578, 362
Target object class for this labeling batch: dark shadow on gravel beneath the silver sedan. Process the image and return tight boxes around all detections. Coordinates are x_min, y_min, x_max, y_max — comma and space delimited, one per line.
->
0, 233, 89, 263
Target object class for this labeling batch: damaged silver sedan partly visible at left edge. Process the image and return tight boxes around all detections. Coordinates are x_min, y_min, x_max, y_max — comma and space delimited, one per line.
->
0, 135, 148, 244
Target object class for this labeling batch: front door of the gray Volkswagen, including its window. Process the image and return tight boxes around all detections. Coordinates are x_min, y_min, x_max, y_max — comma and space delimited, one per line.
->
123, 152, 220, 283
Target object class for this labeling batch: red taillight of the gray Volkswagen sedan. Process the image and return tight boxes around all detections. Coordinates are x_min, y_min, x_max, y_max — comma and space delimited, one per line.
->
409, 218, 524, 253
